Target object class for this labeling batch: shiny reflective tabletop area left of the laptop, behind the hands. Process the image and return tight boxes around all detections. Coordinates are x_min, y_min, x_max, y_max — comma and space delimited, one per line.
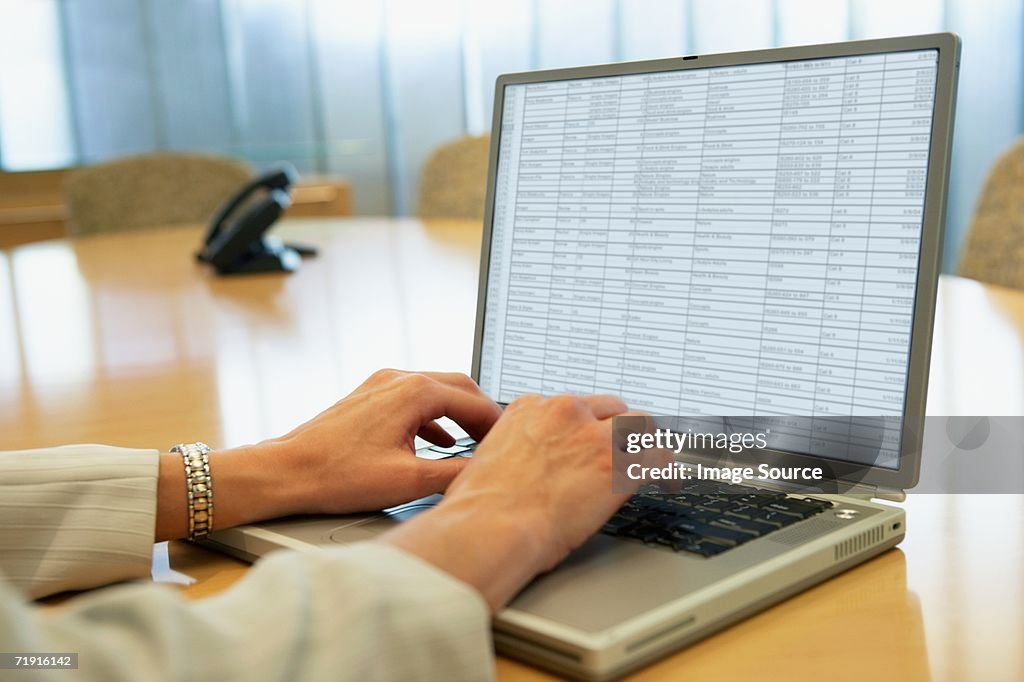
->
0, 220, 480, 447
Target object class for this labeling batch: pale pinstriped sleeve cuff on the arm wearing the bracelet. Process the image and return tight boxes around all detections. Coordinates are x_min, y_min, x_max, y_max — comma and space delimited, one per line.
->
0, 445, 159, 598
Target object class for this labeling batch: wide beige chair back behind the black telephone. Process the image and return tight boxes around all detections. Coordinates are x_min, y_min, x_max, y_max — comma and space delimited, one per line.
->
65, 153, 252, 235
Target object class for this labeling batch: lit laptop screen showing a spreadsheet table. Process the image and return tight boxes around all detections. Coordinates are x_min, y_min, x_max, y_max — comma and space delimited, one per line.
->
478, 49, 938, 466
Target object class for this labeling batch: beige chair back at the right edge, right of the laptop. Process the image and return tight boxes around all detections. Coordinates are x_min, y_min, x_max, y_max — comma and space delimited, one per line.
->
959, 138, 1024, 289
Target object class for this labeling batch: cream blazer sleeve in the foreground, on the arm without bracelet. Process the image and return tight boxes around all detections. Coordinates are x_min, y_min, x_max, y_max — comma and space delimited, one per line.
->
0, 543, 494, 682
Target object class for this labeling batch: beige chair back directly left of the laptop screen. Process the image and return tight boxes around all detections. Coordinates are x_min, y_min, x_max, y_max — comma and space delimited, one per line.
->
417, 135, 490, 220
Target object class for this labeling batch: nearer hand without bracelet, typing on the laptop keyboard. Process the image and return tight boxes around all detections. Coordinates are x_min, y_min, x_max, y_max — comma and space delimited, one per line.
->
380, 395, 628, 609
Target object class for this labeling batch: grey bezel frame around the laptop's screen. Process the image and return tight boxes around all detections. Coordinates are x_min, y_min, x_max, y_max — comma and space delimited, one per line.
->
472, 33, 961, 492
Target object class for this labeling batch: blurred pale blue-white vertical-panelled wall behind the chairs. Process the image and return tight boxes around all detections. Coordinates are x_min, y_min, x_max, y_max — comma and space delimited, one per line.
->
0, 0, 1024, 270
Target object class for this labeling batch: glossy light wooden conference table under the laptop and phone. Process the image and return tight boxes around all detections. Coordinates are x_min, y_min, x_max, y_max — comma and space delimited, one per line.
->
0, 219, 1024, 680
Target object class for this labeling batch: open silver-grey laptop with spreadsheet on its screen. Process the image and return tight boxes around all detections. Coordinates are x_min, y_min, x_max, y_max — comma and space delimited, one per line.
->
208, 34, 959, 680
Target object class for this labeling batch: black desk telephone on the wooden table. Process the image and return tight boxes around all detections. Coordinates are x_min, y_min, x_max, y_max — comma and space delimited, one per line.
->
196, 165, 316, 274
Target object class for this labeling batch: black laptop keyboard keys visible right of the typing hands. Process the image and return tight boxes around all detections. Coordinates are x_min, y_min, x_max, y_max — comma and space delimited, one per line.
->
601, 481, 833, 557
